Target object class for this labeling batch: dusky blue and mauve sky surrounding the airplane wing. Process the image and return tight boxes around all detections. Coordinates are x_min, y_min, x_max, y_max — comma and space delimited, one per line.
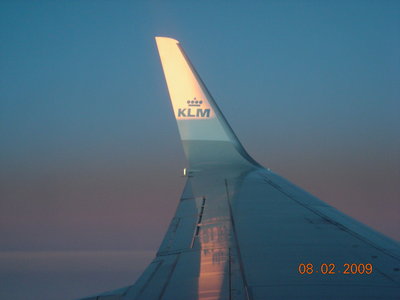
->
0, 1, 400, 299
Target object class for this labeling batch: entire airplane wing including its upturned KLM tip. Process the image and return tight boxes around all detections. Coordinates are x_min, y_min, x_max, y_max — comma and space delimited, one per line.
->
79, 37, 400, 300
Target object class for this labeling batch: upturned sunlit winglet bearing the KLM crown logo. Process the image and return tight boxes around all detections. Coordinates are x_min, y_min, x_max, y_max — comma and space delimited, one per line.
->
156, 37, 259, 168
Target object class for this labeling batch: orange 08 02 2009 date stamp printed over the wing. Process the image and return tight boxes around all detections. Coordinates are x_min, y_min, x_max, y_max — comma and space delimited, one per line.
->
297, 263, 373, 275
